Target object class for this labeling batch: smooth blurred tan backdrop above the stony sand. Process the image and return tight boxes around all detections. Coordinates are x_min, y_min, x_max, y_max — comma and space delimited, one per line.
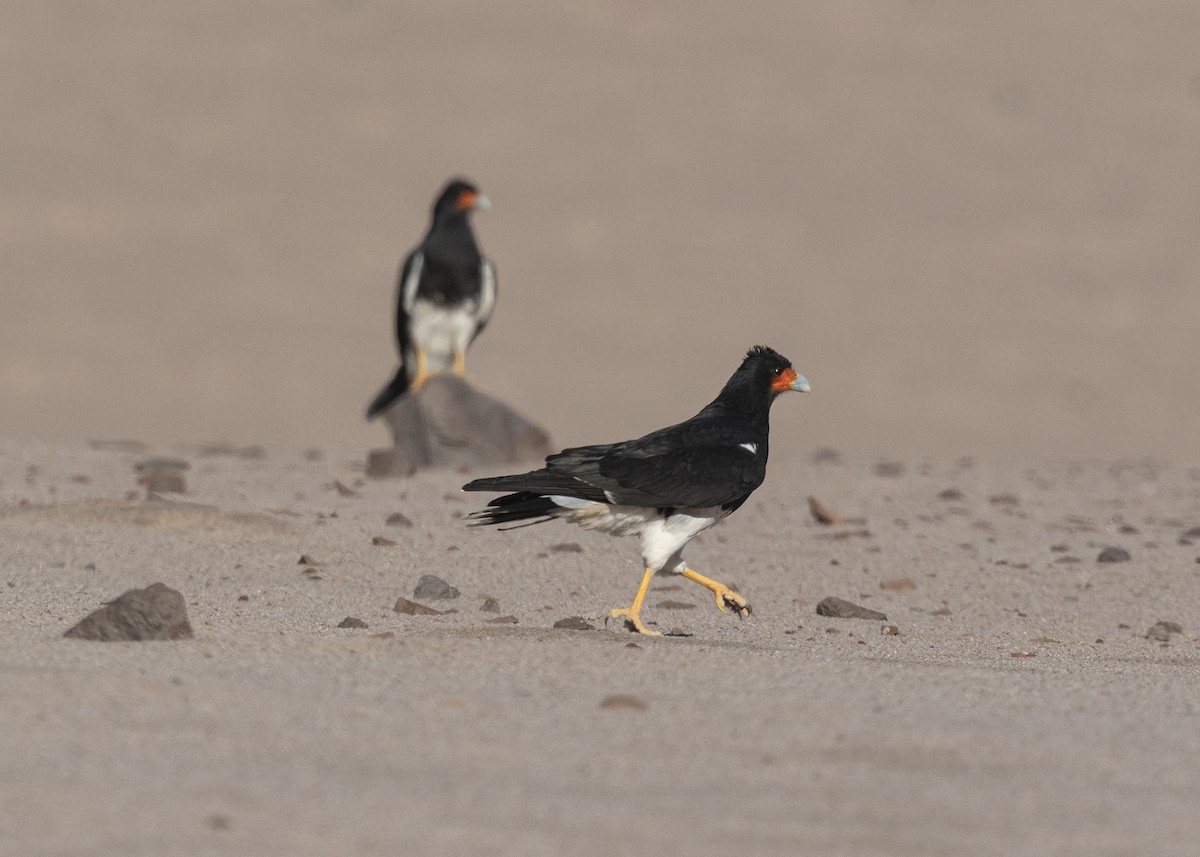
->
0, 0, 1200, 459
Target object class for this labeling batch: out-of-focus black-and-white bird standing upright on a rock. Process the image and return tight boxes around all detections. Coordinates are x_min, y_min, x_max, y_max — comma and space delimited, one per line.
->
367, 179, 496, 420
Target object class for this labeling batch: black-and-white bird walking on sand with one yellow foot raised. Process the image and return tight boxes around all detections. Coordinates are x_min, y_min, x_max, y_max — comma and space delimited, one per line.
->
463, 346, 809, 636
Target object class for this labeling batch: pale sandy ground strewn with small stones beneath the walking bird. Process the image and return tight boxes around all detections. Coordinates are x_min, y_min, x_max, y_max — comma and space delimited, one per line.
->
0, 436, 1200, 857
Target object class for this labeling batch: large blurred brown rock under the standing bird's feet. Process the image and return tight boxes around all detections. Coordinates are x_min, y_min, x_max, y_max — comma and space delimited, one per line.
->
367, 374, 556, 479
